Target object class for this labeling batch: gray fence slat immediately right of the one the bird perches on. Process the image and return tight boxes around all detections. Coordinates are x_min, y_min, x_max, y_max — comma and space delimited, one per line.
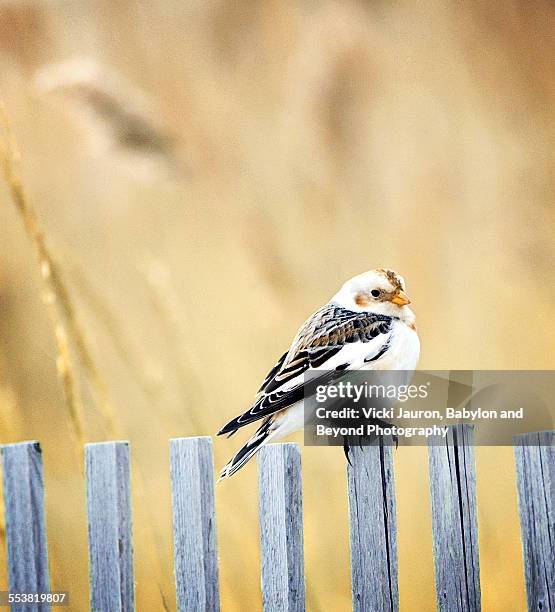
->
428, 424, 481, 612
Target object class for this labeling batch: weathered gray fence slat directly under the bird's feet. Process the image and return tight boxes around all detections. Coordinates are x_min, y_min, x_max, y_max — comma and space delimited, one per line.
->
347, 441, 399, 612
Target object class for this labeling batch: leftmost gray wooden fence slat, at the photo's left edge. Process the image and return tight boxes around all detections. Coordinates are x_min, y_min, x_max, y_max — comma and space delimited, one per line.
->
2, 442, 50, 612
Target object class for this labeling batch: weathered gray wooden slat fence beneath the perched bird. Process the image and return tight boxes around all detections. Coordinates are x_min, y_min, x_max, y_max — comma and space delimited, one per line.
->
2, 425, 555, 612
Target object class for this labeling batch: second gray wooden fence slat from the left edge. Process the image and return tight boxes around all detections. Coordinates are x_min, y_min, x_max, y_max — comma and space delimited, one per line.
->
85, 442, 135, 612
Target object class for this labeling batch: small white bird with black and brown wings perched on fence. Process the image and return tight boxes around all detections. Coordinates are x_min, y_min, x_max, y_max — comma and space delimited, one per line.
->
218, 268, 420, 480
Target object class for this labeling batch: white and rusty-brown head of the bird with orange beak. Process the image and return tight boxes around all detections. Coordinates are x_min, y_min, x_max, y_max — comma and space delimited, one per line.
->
332, 268, 412, 319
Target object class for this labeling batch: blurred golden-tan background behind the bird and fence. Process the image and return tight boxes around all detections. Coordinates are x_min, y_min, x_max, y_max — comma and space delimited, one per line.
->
0, 0, 555, 612
